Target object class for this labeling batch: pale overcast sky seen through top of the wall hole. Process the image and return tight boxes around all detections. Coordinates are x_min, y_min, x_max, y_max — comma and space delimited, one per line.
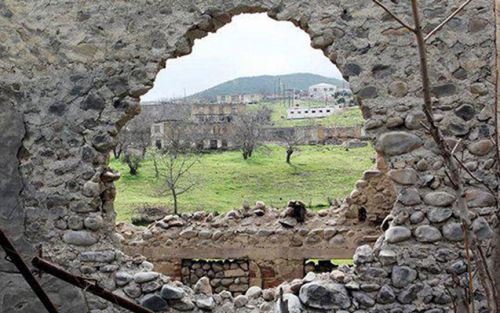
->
142, 14, 341, 101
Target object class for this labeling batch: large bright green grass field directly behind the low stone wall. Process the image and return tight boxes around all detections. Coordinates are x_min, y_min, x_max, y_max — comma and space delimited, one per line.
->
110, 146, 374, 221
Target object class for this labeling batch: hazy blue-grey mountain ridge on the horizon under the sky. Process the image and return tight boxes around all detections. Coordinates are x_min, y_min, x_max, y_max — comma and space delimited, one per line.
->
188, 73, 349, 99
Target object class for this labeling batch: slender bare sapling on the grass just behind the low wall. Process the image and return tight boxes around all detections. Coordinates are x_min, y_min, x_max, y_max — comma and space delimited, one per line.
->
157, 120, 200, 214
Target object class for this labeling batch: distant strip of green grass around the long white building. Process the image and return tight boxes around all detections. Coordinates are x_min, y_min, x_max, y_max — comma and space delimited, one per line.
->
250, 100, 364, 127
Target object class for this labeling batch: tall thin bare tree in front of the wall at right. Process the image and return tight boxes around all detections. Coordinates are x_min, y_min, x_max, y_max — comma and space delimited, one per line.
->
372, 0, 498, 313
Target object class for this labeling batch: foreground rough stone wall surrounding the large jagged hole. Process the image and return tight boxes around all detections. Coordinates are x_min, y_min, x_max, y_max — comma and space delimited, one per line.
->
0, 0, 497, 312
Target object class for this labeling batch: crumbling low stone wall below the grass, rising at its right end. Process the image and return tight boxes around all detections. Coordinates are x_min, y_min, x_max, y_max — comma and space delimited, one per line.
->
118, 164, 396, 294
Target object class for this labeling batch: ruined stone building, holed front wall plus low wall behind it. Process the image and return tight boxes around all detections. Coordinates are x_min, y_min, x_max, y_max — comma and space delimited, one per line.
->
0, 0, 500, 313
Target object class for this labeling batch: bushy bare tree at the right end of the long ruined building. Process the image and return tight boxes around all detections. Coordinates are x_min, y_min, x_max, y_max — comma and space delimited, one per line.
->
233, 108, 271, 160
